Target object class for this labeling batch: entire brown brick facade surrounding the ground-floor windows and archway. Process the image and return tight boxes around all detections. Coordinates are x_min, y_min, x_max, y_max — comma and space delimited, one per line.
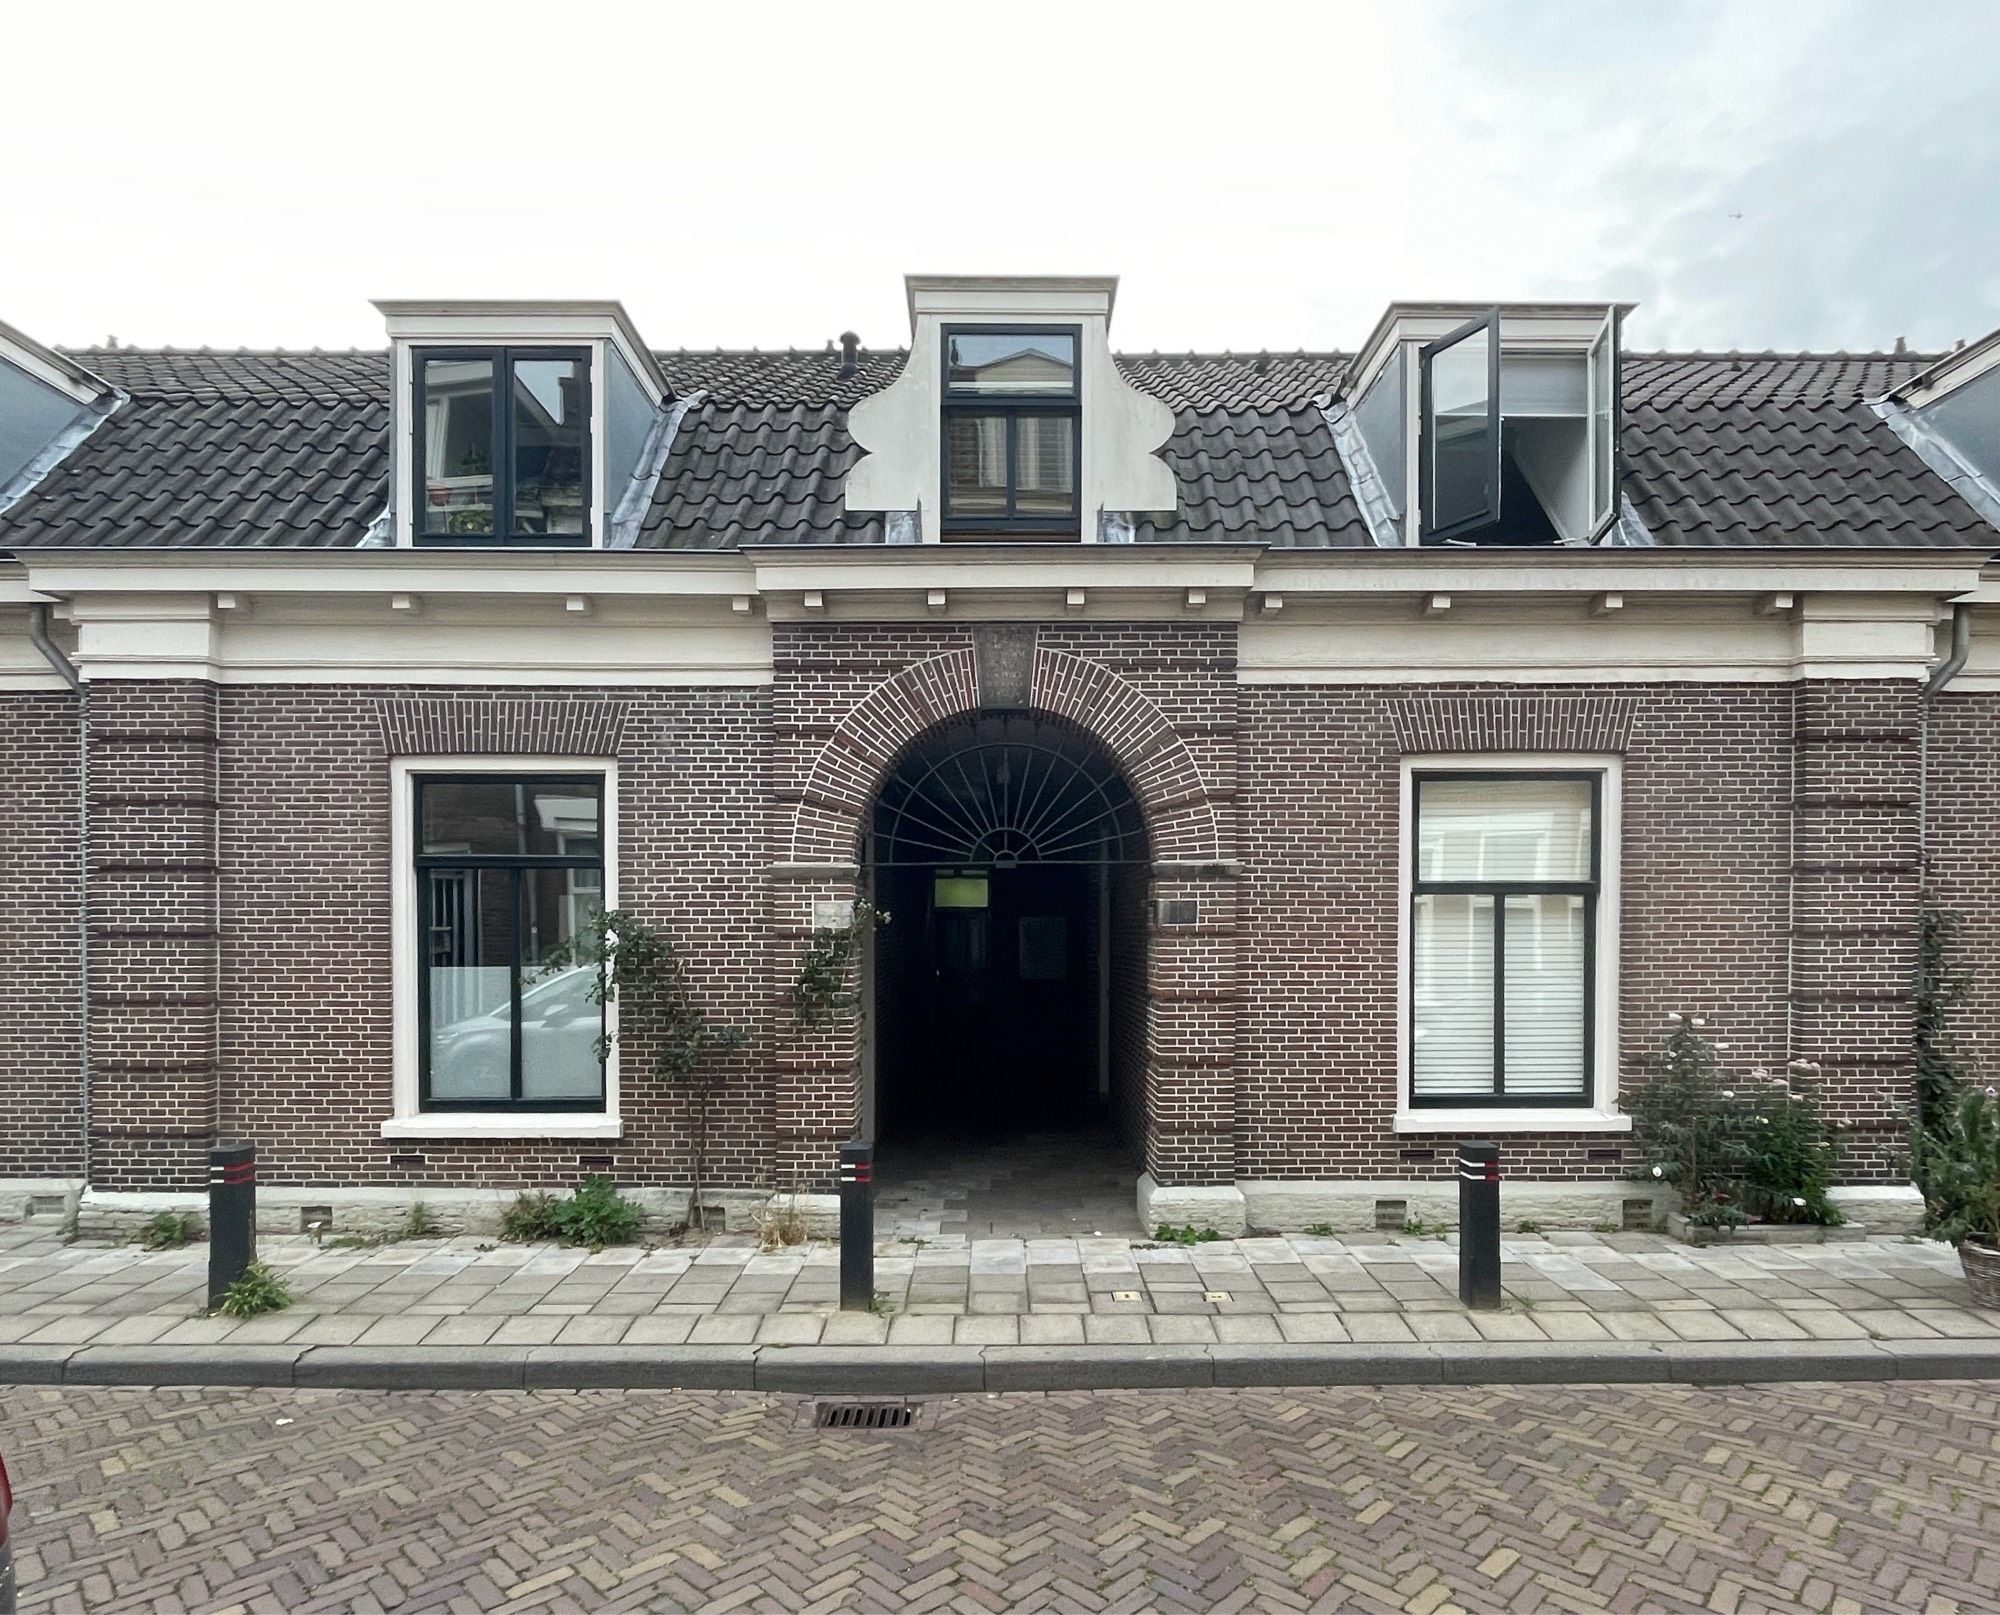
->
0, 622, 1952, 1187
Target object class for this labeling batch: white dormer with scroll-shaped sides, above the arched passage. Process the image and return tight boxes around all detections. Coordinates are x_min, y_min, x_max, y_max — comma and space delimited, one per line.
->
844, 276, 1176, 544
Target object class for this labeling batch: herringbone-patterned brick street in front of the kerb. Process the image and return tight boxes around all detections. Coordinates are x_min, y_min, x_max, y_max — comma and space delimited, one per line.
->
0, 1383, 2000, 1615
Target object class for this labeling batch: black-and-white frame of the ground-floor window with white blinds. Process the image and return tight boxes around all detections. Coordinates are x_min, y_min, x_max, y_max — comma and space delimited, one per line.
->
1402, 768, 1606, 1111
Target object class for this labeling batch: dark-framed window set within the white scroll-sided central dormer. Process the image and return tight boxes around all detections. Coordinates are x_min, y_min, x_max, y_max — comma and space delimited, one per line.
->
942, 326, 1082, 538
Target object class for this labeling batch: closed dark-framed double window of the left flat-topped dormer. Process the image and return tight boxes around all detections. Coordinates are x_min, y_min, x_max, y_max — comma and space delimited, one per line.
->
412, 348, 590, 544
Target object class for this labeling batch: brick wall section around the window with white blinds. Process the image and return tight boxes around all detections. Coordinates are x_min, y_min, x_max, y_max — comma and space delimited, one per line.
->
1238, 684, 1792, 1177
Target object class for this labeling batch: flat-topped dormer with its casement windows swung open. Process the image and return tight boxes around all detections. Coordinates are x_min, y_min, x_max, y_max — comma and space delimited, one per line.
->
1332, 304, 1630, 546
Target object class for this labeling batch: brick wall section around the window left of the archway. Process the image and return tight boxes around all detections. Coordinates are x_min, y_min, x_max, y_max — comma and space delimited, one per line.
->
220, 686, 774, 1185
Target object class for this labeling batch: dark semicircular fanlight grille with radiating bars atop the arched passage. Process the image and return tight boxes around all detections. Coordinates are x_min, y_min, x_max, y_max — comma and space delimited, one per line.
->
876, 714, 1146, 869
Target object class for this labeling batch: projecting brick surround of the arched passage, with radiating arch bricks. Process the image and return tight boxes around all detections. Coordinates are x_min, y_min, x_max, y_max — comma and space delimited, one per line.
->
772, 630, 1240, 1183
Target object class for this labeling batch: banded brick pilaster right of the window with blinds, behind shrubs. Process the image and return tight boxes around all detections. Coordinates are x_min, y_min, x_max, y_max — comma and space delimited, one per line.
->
1792, 680, 1920, 1177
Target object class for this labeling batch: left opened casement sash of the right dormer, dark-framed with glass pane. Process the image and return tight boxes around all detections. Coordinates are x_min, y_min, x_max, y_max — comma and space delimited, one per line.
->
1418, 308, 1500, 544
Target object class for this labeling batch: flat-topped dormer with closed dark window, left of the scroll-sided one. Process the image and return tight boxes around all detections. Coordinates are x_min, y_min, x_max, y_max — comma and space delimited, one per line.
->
376, 300, 672, 550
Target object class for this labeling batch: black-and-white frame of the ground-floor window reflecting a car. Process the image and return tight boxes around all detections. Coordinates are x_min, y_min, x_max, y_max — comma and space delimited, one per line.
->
406, 770, 610, 1115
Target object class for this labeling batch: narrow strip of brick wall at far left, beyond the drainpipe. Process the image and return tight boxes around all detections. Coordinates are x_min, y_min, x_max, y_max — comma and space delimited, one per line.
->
0, 692, 84, 1177
